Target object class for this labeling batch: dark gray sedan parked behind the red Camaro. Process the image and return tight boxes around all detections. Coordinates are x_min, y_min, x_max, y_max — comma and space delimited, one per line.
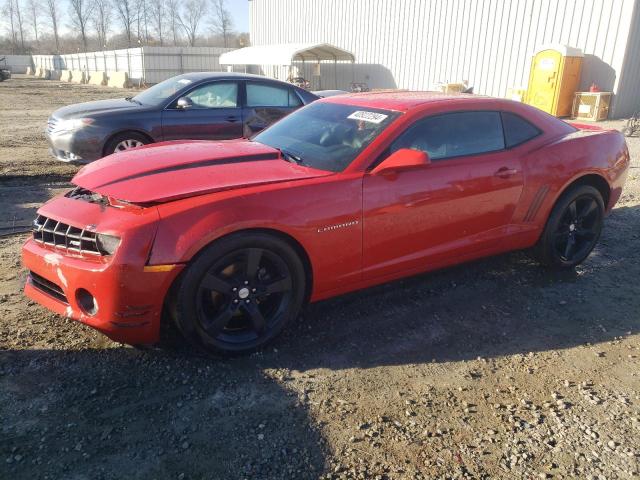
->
46, 72, 318, 162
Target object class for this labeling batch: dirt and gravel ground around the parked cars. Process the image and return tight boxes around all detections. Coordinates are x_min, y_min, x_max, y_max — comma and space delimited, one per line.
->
0, 76, 640, 479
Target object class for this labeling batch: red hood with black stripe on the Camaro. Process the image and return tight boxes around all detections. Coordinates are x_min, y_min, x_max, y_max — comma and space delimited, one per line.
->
73, 140, 332, 204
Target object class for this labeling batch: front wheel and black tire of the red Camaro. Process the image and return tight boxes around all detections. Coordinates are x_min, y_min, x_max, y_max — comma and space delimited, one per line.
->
170, 233, 305, 355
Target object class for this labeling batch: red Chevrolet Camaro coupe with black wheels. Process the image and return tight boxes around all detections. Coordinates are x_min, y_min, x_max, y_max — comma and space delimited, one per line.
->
23, 92, 629, 353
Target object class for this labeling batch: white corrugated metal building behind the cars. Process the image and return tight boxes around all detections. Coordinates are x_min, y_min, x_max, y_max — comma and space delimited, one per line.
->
249, 0, 640, 117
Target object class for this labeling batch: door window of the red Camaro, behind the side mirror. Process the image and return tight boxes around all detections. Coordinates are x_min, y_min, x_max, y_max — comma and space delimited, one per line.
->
391, 112, 504, 160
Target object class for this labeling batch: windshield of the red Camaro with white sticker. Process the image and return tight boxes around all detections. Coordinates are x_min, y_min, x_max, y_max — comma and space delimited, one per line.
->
252, 102, 398, 172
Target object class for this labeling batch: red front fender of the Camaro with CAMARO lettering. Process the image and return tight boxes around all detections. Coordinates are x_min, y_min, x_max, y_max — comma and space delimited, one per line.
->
149, 175, 362, 292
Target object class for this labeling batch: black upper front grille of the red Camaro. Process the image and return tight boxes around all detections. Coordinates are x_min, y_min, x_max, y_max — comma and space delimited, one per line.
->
33, 215, 102, 255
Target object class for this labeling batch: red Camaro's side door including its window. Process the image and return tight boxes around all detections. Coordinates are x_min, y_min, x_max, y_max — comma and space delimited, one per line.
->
363, 111, 523, 279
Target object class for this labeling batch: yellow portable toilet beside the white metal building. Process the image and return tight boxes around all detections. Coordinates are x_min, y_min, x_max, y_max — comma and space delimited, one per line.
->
525, 45, 583, 117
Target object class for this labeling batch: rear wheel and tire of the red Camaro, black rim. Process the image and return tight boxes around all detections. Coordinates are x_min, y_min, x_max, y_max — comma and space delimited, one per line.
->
535, 185, 604, 269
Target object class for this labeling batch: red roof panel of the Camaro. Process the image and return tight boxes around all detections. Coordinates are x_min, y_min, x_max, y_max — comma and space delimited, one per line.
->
322, 90, 506, 112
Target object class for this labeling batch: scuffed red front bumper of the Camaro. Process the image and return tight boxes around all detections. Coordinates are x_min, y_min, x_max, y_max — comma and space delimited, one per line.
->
22, 197, 183, 344
